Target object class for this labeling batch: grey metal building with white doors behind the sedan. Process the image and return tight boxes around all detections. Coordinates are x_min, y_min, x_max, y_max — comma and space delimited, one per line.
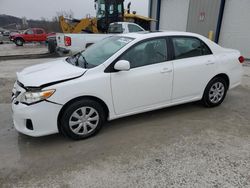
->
149, 0, 250, 58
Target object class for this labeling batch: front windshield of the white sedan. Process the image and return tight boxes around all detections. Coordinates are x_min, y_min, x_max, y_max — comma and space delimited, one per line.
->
66, 36, 133, 68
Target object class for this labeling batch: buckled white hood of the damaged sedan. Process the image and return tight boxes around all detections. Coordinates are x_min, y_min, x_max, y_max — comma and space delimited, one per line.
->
17, 58, 87, 87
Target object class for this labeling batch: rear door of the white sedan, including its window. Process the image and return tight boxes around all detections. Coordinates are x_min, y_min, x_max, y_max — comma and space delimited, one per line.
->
171, 36, 216, 102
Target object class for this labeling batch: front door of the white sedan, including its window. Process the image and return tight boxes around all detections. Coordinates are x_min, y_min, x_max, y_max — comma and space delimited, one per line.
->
111, 38, 173, 115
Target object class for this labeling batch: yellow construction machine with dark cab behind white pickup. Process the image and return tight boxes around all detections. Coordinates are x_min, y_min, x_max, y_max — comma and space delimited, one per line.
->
59, 0, 156, 33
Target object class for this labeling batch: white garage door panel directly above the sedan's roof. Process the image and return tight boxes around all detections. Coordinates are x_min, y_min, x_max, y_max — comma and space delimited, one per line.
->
160, 0, 189, 31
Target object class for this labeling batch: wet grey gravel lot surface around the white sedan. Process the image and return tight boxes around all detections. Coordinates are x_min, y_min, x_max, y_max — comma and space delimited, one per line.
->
0, 59, 250, 187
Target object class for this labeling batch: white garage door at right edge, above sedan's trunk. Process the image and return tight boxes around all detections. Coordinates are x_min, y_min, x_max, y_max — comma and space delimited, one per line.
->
219, 0, 250, 58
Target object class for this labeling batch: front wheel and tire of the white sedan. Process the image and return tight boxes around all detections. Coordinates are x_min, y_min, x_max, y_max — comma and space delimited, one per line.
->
59, 99, 106, 140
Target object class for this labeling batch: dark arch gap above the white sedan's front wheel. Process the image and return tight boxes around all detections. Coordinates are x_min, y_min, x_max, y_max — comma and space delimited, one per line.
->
57, 95, 109, 132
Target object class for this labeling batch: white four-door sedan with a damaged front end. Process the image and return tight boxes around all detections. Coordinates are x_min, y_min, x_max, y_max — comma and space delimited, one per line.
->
12, 32, 244, 139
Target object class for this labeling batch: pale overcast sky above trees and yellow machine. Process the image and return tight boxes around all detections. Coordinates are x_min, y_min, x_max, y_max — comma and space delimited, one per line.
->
0, 0, 149, 19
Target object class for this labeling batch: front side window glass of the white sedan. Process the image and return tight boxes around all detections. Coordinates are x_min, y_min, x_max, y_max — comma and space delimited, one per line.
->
119, 38, 167, 68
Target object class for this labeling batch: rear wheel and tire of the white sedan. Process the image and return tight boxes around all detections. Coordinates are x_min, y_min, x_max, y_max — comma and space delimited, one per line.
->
202, 77, 228, 107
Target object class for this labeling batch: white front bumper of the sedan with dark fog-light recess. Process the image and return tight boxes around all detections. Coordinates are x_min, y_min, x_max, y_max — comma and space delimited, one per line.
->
12, 101, 62, 137
